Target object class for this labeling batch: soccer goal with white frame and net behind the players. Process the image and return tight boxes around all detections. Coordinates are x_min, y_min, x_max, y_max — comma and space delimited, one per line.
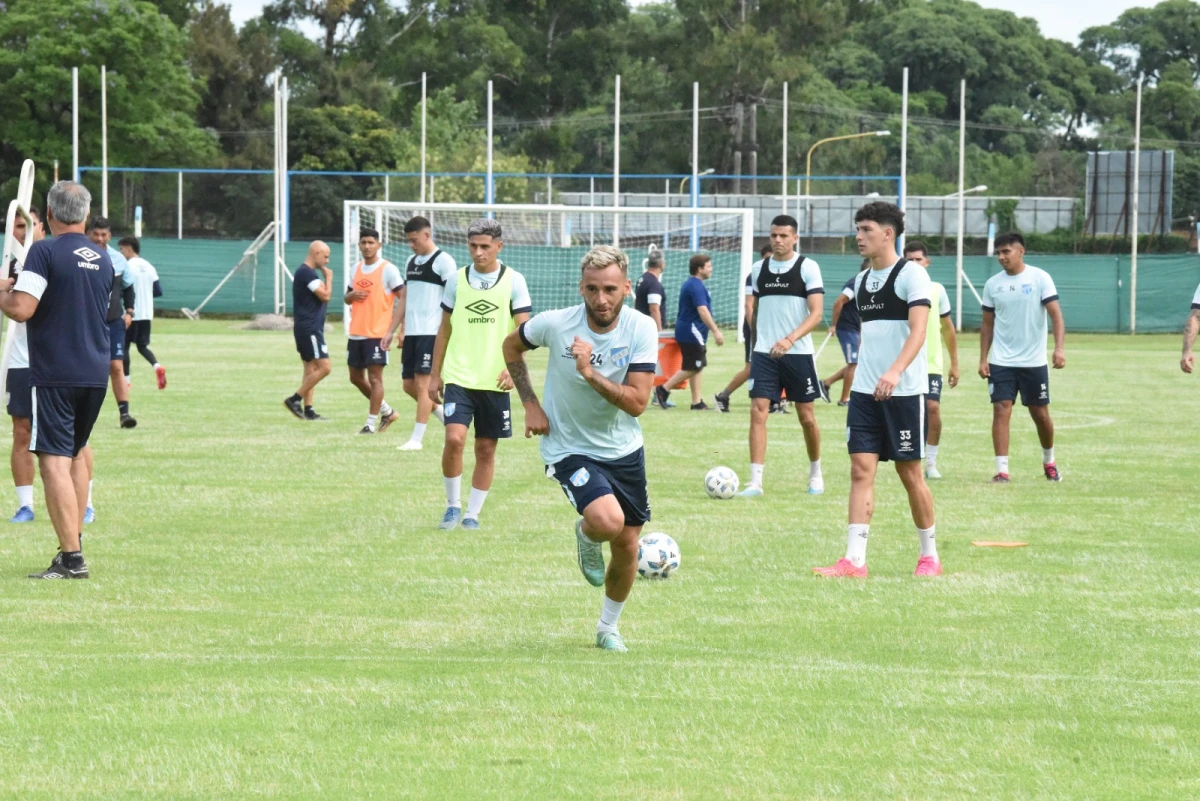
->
342, 200, 755, 337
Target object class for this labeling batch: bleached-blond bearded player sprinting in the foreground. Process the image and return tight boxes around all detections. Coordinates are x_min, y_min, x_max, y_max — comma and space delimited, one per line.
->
504, 245, 658, 651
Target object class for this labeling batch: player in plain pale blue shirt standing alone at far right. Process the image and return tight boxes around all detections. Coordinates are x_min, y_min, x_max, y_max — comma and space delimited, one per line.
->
979, 234, 1067, 483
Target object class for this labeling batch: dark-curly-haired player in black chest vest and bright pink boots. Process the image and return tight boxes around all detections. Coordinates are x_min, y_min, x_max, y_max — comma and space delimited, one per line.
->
814, 201, 942, 578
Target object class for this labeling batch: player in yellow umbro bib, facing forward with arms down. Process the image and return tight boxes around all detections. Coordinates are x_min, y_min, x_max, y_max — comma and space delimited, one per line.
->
430, 218, 533, 530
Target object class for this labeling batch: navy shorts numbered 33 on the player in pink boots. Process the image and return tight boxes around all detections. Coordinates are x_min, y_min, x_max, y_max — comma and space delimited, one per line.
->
846, 392, 925, 462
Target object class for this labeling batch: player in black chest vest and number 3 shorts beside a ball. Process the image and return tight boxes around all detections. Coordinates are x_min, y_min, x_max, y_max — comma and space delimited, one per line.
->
738, 215, 829, 498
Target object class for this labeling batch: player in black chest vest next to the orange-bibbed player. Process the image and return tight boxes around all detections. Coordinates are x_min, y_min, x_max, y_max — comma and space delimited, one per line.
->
383, 217, 458, 451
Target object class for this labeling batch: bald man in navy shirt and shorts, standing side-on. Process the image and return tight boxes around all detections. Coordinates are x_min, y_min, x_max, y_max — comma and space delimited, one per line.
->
283, 241, 334, 420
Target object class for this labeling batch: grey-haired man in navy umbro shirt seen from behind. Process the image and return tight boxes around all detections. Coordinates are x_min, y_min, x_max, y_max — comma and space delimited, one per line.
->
0, 181, 111, 578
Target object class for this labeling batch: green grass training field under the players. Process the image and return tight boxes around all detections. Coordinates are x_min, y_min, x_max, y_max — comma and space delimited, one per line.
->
0, 320, 1200, 799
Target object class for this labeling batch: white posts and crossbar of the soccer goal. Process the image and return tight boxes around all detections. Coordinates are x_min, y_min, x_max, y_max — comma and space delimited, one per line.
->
342, 200, 756, 342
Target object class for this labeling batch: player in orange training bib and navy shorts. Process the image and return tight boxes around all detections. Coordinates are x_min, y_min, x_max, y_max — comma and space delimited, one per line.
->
344, 228, 404, 434
